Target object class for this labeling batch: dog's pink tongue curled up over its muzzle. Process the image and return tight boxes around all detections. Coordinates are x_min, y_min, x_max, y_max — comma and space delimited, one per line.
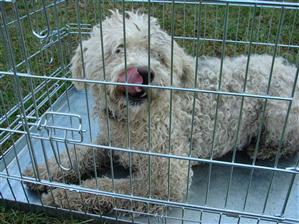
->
117, 67, 143, 94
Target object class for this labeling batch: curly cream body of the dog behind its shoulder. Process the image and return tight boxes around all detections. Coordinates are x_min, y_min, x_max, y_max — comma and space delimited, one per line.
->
184, 55, 299, 158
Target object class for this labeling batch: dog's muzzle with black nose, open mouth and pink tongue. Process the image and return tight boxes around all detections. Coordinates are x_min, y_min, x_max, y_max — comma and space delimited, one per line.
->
117, 66, 155, 105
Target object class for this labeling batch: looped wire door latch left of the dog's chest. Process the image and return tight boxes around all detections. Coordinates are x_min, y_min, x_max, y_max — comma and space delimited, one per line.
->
18, 111, 86, 142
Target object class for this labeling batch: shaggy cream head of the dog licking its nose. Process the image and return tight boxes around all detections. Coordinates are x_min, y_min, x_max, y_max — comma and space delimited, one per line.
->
71, 11, 194, 119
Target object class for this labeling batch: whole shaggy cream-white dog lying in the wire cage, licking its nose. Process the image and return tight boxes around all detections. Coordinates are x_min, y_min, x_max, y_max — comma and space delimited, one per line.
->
26, 11, 299, 213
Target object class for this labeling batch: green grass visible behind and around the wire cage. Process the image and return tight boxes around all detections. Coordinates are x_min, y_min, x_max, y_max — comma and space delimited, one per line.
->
0, 0, 299, 223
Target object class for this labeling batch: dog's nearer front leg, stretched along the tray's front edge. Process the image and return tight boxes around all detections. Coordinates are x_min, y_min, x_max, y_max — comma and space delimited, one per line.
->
42, 157, 192, 214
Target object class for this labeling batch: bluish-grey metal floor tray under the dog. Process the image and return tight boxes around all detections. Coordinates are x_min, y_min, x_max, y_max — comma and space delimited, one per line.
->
0, 89, 299, 223
